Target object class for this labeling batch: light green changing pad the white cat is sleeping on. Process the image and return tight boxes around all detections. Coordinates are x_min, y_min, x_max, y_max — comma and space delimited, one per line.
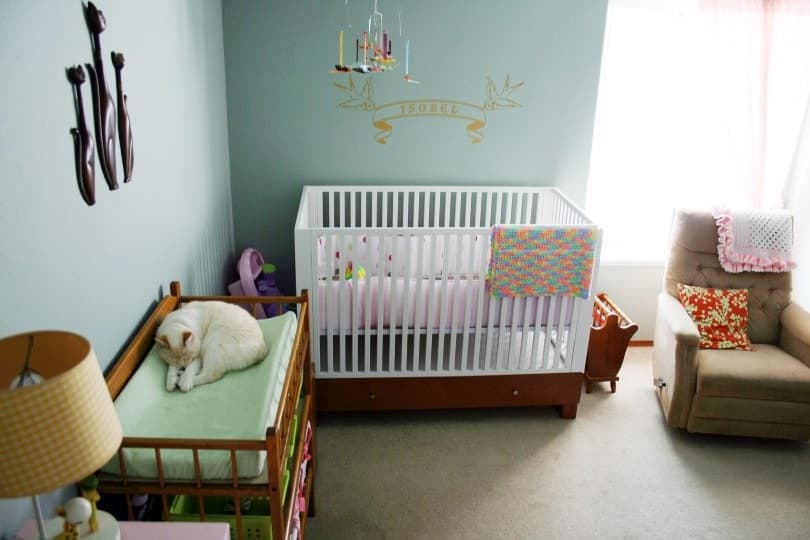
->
102, 312, 297, 480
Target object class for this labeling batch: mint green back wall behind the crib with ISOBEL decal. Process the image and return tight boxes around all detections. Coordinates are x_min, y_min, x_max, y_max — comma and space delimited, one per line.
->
223, 0, 607, 291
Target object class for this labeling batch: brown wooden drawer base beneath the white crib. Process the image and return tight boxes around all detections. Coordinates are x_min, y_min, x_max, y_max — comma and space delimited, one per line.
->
316, 373, 582, 418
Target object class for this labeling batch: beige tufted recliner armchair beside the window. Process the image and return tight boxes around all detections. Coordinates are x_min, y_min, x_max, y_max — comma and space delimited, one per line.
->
653, 210, 810, 440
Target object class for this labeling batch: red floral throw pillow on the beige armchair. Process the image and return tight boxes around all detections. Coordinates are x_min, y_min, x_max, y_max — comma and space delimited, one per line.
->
678, 283, 754, 351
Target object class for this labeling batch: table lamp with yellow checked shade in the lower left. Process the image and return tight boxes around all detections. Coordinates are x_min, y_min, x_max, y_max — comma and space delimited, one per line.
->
0, 330, 121, 538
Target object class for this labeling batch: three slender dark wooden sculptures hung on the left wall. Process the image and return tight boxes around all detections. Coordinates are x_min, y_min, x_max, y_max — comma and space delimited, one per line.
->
67, 2, 134, 205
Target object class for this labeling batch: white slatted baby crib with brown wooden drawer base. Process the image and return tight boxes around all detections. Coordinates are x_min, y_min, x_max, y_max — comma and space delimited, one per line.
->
295, 186, 602, 418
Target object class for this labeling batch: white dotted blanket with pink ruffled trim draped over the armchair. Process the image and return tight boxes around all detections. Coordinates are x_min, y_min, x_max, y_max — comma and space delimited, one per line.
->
712, 209, 796, 273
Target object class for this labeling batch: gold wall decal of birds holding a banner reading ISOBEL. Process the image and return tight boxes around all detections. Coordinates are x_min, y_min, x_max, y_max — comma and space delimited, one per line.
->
334, 75, 523, 144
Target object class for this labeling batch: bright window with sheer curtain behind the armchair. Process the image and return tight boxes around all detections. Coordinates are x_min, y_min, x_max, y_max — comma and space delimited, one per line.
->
586, 0, 810, 261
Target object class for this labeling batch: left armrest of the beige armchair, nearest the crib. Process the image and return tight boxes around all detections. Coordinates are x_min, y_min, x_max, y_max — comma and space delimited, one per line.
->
653, 292, 700, 427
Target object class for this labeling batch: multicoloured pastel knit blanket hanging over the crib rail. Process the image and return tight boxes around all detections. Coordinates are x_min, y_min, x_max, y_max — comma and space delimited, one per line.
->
488, 225, 597, 298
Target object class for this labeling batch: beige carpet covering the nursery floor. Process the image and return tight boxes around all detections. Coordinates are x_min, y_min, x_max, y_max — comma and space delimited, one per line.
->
307, 347, 810, 540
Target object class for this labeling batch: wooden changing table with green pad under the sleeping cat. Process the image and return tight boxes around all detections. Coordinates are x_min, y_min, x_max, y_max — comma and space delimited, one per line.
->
99, 282, 316, 539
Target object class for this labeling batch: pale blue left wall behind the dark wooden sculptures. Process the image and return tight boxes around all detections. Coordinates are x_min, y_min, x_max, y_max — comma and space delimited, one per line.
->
0, 0, 233, 537
